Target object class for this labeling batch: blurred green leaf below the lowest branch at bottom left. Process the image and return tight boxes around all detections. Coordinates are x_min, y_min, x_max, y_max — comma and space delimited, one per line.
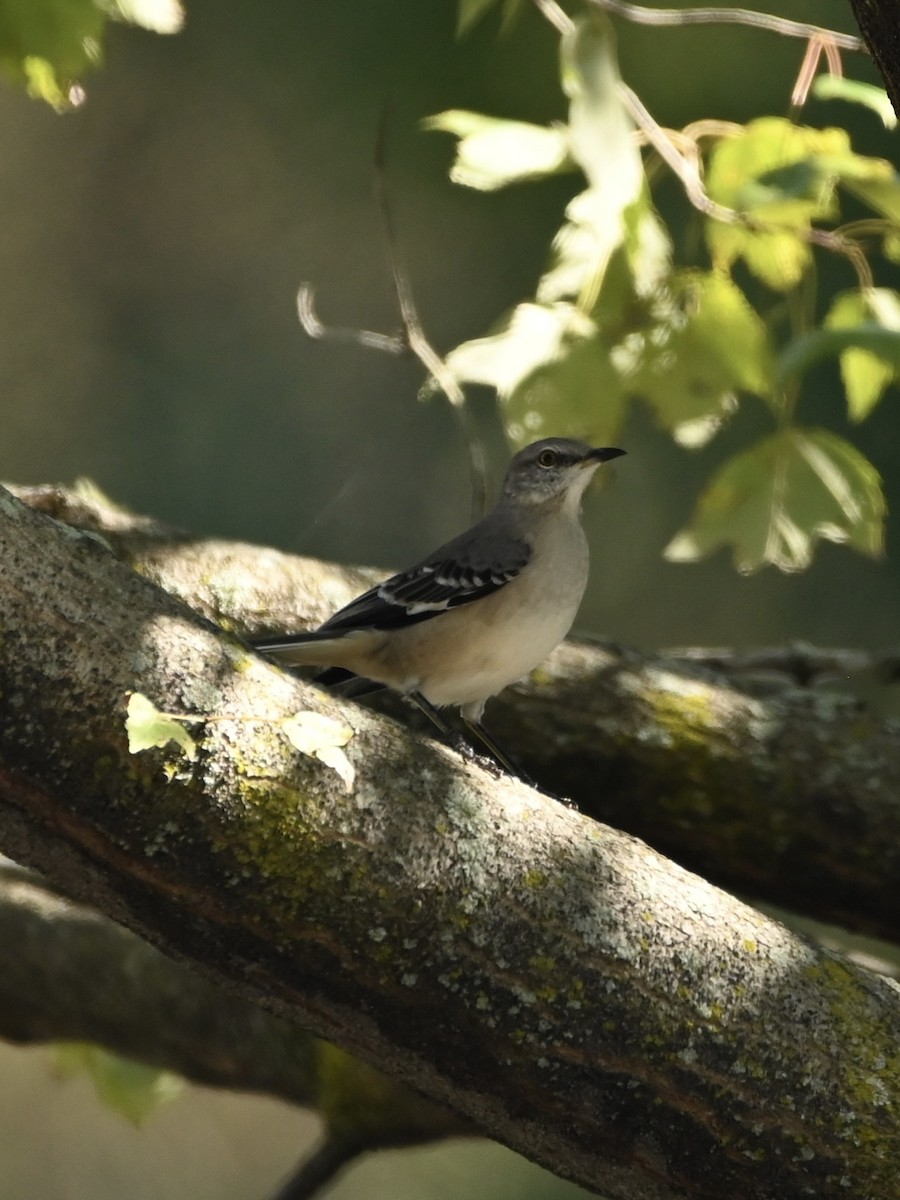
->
56, 1042, 184, 1126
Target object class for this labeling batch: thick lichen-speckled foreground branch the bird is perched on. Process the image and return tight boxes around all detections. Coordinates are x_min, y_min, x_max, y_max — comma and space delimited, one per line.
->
0, 480, 900, 1200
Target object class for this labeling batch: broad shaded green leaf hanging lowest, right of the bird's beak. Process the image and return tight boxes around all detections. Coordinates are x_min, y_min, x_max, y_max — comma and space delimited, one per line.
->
666, 428, 884, 572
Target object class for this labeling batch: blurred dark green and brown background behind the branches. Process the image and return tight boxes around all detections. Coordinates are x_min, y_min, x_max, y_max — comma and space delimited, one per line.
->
0, 0, 900, 1200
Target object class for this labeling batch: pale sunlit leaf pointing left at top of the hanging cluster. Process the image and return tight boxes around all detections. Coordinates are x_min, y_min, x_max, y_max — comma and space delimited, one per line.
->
421, 109, 571, 192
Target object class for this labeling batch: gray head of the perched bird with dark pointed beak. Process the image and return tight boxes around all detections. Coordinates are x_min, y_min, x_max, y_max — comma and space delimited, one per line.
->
502, 438, 625, 514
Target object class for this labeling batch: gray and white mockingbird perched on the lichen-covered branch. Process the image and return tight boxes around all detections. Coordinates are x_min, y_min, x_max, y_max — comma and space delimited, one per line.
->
253, 438, 625, 774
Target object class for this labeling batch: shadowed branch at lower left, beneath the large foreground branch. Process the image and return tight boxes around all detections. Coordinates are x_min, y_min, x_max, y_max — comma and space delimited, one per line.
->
0, 864, 470, 1148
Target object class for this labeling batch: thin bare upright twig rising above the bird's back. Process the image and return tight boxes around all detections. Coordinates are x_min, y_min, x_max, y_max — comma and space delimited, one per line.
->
374, 106, 487, 518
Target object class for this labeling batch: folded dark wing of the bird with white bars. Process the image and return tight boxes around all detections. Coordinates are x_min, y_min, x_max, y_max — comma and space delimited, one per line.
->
316, 522, 532, 637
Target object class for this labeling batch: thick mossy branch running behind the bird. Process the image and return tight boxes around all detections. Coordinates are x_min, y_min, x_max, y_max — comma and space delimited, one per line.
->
19, 488, 900, 941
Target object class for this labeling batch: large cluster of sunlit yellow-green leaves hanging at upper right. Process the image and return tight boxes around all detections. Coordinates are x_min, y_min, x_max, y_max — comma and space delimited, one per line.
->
425, 7, 900, 571
